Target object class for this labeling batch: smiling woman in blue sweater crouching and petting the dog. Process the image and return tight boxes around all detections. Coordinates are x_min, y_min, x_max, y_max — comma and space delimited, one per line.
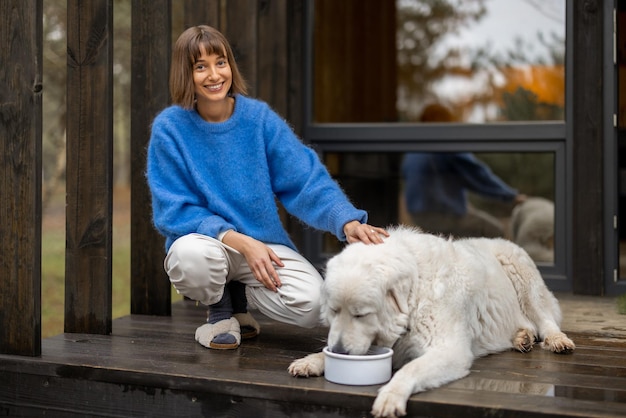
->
147, 26, 387, 349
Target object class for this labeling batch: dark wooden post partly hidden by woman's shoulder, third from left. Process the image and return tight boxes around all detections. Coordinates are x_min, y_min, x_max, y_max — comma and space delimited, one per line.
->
130, 0, 171, 315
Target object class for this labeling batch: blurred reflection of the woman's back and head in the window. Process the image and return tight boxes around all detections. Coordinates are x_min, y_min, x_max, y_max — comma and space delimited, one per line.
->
402, 104, 525, 237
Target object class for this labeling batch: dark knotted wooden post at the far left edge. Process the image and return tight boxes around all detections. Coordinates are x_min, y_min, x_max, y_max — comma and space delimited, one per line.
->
0, 0, 42, 356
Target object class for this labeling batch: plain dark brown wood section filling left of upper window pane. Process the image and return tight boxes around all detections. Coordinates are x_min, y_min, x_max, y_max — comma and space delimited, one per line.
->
313, 0, 397, 122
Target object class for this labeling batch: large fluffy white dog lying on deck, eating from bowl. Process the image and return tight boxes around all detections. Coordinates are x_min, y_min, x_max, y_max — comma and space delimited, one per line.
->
289, 227, 575, 417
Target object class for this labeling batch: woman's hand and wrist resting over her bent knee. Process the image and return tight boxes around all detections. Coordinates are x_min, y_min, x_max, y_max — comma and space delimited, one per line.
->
222, 231, 284, 292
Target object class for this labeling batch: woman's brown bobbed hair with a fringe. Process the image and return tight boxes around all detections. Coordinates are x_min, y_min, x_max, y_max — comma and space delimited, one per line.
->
170, 25, 248, 109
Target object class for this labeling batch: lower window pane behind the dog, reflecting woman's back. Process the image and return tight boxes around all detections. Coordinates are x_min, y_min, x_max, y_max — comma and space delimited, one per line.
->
324, 152, 555, 264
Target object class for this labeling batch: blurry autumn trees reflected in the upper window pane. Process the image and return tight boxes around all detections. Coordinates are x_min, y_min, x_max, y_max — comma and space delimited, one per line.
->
397, 0, 565, 121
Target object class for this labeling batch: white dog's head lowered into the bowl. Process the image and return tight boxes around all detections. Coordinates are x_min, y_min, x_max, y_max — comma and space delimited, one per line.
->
322, 233, 416, 355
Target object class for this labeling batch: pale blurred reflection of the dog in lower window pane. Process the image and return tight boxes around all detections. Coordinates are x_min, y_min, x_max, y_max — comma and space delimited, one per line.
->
511, 197, 554, 263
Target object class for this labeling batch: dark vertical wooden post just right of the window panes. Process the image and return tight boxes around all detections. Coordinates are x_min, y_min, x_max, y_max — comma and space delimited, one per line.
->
567, 0, 612, 295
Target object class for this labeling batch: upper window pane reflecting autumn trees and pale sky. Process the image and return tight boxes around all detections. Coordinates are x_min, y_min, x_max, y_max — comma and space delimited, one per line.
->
313, 0, 565, 123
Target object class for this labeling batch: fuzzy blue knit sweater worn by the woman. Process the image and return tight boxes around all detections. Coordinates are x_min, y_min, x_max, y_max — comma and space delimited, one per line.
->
147, 95, 367, 249
